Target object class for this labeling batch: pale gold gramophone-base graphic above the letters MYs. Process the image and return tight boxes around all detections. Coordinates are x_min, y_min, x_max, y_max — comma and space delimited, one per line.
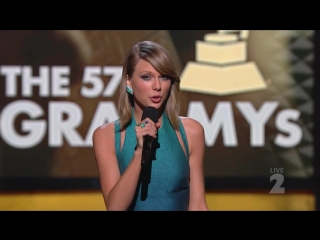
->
180, 30, 267, 95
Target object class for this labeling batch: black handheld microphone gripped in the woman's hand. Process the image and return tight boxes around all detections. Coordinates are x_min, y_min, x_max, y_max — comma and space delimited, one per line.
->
141, 106, 158, 166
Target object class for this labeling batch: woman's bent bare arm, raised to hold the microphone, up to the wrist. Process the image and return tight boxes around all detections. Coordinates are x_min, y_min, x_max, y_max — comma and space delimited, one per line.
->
92, 122, 142, 210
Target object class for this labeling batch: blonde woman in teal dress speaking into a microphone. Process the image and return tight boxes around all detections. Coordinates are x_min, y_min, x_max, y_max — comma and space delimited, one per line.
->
93, 41, 208, 211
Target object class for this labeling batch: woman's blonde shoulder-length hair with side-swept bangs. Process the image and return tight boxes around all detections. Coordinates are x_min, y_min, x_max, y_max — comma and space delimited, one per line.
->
118, 41, 180, 130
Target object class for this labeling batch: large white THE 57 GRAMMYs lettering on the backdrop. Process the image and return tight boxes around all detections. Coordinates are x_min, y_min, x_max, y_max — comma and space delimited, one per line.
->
0, 66, 302, 148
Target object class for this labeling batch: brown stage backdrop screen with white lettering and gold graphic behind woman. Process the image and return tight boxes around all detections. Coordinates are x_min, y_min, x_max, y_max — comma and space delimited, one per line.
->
0, 30, 314, 192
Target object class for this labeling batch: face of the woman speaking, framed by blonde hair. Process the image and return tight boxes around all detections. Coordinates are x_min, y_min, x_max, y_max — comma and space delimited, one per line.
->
127, 59, 171, 109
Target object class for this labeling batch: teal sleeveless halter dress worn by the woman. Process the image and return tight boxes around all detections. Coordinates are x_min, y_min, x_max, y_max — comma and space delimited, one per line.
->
115, 114, 190, 211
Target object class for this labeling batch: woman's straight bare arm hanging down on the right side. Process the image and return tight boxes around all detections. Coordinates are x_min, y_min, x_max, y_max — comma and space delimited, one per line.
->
181, 118, 209, 211
